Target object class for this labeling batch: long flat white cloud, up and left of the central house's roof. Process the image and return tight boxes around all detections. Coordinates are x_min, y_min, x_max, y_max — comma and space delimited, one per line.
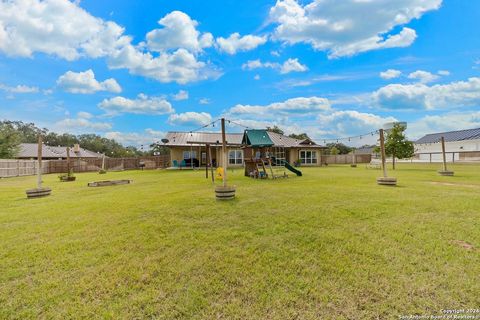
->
98, 94, 175, 115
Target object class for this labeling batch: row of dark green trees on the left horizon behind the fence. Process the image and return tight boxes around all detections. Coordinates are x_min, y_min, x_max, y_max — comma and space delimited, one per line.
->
0, 120, 166, 159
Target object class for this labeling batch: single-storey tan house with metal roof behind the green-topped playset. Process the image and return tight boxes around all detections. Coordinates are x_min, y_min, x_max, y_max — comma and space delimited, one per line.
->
165, 130, 324, 167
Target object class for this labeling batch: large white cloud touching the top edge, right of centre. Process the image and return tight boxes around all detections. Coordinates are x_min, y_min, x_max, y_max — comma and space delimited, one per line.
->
269, 0, 442, 58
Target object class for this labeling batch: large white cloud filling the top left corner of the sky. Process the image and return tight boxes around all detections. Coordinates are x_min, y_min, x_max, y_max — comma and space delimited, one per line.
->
0, 0, 130, 60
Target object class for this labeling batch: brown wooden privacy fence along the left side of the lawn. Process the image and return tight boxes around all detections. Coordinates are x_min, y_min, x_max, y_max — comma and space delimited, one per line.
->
0, 155, 170, 178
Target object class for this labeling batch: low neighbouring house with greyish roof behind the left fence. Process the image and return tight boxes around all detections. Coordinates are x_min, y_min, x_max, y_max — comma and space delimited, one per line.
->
16, 143, 102, 160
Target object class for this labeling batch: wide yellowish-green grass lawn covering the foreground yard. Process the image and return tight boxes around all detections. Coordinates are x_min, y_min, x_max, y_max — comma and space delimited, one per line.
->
0, 164, 480, 319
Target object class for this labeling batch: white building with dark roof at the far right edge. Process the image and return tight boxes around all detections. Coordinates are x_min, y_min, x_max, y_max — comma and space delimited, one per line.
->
414, 128, 480, 162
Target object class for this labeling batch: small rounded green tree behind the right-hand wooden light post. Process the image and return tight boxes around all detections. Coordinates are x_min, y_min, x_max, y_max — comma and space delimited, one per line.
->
385, 124, 415, 170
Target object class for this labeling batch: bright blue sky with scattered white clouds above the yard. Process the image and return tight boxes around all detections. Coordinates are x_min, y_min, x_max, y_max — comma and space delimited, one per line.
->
0, 0, 480, 145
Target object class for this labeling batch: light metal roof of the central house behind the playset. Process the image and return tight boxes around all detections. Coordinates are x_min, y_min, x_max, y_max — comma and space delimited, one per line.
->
165, 131, 320, 148
